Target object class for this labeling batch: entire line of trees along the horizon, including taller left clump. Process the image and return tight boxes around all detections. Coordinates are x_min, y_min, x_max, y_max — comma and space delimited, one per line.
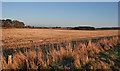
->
0, 19, 120, 30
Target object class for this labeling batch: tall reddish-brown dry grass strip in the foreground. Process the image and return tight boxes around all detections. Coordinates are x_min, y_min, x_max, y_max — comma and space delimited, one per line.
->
2, 37, 118, 69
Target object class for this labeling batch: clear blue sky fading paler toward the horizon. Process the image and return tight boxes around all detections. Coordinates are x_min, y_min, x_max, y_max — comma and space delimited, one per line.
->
2, 2, 118, 27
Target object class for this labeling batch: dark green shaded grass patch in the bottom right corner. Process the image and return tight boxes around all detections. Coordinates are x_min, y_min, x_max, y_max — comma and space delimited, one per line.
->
82, 44, 120, 71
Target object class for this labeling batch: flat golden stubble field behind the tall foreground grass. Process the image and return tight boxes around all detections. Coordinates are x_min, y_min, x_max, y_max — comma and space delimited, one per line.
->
2, 29, 118, 48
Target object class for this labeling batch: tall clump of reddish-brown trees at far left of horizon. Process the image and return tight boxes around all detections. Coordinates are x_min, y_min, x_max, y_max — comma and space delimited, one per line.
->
0, 19, 25, 28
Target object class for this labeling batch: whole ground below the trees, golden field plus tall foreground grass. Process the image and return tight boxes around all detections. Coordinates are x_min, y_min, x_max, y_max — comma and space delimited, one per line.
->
2, 29, 119, 69
